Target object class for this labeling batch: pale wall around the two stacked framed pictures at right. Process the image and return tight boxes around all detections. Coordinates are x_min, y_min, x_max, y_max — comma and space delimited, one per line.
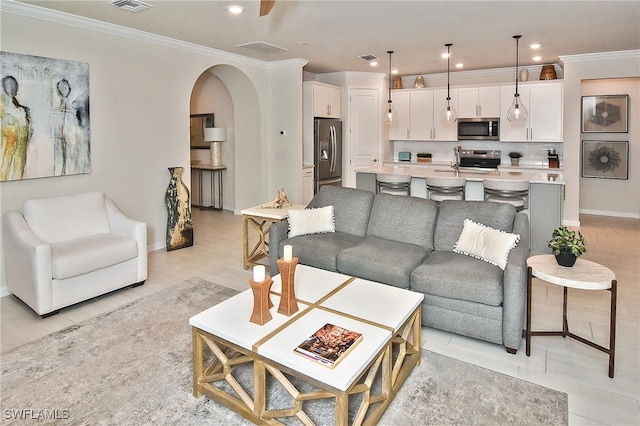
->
580, 78, 640, 219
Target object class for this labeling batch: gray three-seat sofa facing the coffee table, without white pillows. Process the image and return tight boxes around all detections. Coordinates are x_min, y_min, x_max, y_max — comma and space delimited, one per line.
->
269, 186, 529, 353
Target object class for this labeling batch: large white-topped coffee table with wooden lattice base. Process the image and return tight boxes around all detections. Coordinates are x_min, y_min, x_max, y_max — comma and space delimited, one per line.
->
189, 265, 423, 425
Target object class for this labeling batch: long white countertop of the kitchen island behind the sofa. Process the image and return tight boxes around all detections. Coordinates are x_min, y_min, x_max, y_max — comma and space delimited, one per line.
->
357, 162, 564, 185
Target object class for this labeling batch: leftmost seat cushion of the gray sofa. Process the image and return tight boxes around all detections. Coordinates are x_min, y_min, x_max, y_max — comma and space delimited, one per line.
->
279, 232, 363, 271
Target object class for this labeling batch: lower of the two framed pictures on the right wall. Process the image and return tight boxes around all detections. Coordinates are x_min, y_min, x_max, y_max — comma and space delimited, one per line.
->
582, 141, 629, 179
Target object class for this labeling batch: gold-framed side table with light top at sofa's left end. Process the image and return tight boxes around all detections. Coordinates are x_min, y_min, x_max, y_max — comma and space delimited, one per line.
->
240, 204, 306, 270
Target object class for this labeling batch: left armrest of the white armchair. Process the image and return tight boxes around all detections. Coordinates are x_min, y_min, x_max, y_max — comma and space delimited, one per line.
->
2, 210, 53, 315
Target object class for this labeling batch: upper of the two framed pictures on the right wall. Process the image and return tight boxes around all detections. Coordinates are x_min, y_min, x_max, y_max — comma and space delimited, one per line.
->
582, 95, 629, 133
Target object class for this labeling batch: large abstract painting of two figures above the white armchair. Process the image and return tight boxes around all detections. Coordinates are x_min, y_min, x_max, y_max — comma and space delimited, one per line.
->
0, 52, 91, 181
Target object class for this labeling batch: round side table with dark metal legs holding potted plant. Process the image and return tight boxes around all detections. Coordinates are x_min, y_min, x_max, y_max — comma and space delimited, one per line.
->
525, 254, 618, 378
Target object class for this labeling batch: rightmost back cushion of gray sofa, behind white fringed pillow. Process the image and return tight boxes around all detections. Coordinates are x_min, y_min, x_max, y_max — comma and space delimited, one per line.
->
433, 200, 516, 251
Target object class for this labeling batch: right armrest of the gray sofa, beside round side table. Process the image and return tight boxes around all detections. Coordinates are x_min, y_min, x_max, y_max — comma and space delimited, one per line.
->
502, 213, 530, 349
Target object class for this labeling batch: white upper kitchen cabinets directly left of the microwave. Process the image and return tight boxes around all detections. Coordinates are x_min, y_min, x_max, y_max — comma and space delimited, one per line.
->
389, 89, 458, 141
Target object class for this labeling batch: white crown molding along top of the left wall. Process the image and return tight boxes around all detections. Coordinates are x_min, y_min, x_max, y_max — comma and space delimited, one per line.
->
0, 0, 271, 69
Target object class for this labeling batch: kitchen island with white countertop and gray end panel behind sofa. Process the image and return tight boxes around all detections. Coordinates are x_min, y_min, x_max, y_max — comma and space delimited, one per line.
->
356, 163, 564, 253
